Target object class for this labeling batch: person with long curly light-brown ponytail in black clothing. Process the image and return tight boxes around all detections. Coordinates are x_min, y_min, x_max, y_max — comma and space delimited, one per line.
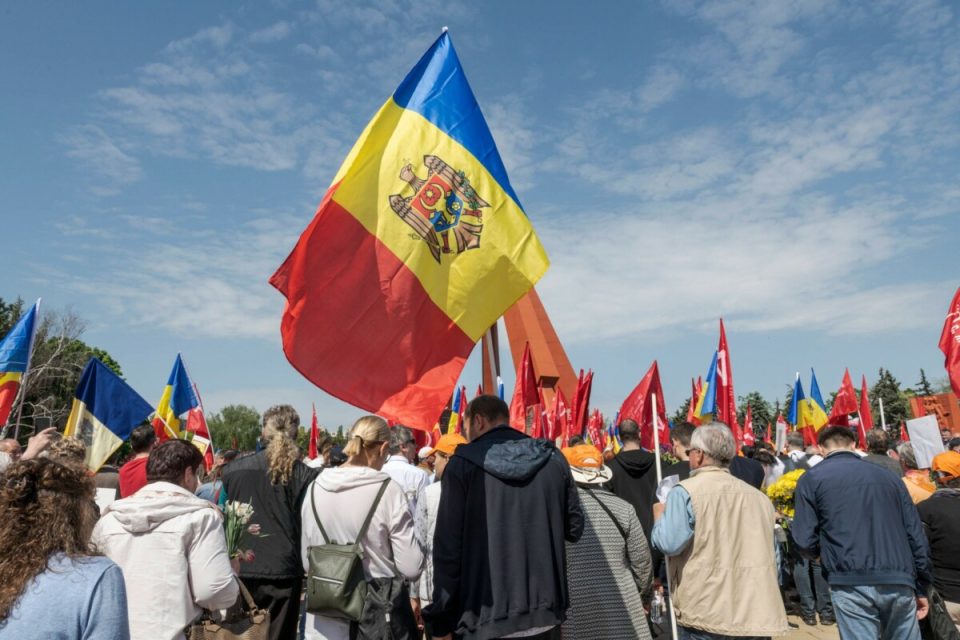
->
223, 405, 318, 640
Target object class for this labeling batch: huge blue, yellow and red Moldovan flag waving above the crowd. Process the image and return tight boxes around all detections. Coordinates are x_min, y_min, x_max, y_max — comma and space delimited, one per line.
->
270, 33, 548, 429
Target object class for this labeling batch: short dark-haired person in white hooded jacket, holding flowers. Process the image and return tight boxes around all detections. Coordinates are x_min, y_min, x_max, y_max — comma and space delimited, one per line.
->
92, 440, 239, 640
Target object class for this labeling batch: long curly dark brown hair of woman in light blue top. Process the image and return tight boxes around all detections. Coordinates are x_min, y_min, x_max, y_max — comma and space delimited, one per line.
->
0, 458, 96, 622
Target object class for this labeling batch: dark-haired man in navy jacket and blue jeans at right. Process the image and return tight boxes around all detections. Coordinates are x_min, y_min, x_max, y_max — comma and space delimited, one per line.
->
793, 426, 931, 640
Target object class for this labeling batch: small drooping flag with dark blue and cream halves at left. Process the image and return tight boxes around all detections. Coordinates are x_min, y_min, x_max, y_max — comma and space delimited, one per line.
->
63, 358, 153, 471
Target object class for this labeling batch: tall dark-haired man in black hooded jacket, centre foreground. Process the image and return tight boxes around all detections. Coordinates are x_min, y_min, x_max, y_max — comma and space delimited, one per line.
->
423, 395, 583, 640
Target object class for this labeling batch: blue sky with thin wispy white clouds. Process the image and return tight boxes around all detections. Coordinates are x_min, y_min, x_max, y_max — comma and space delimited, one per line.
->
0, 0, 960, 426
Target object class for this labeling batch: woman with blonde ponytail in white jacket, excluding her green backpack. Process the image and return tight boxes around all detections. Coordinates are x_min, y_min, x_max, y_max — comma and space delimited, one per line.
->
300, 416, 423, 640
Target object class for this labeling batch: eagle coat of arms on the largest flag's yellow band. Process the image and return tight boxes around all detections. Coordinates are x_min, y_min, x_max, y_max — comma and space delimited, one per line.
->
389, 156, 490, 263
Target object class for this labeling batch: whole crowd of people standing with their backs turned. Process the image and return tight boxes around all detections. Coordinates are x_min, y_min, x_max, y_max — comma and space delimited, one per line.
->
0, 395, 960, 640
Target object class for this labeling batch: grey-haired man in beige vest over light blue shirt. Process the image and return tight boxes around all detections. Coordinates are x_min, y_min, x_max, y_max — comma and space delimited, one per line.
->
652, 422, 788, 640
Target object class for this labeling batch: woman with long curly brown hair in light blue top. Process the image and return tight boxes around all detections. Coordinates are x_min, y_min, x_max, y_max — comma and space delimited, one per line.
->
0, 458, 130, 640
